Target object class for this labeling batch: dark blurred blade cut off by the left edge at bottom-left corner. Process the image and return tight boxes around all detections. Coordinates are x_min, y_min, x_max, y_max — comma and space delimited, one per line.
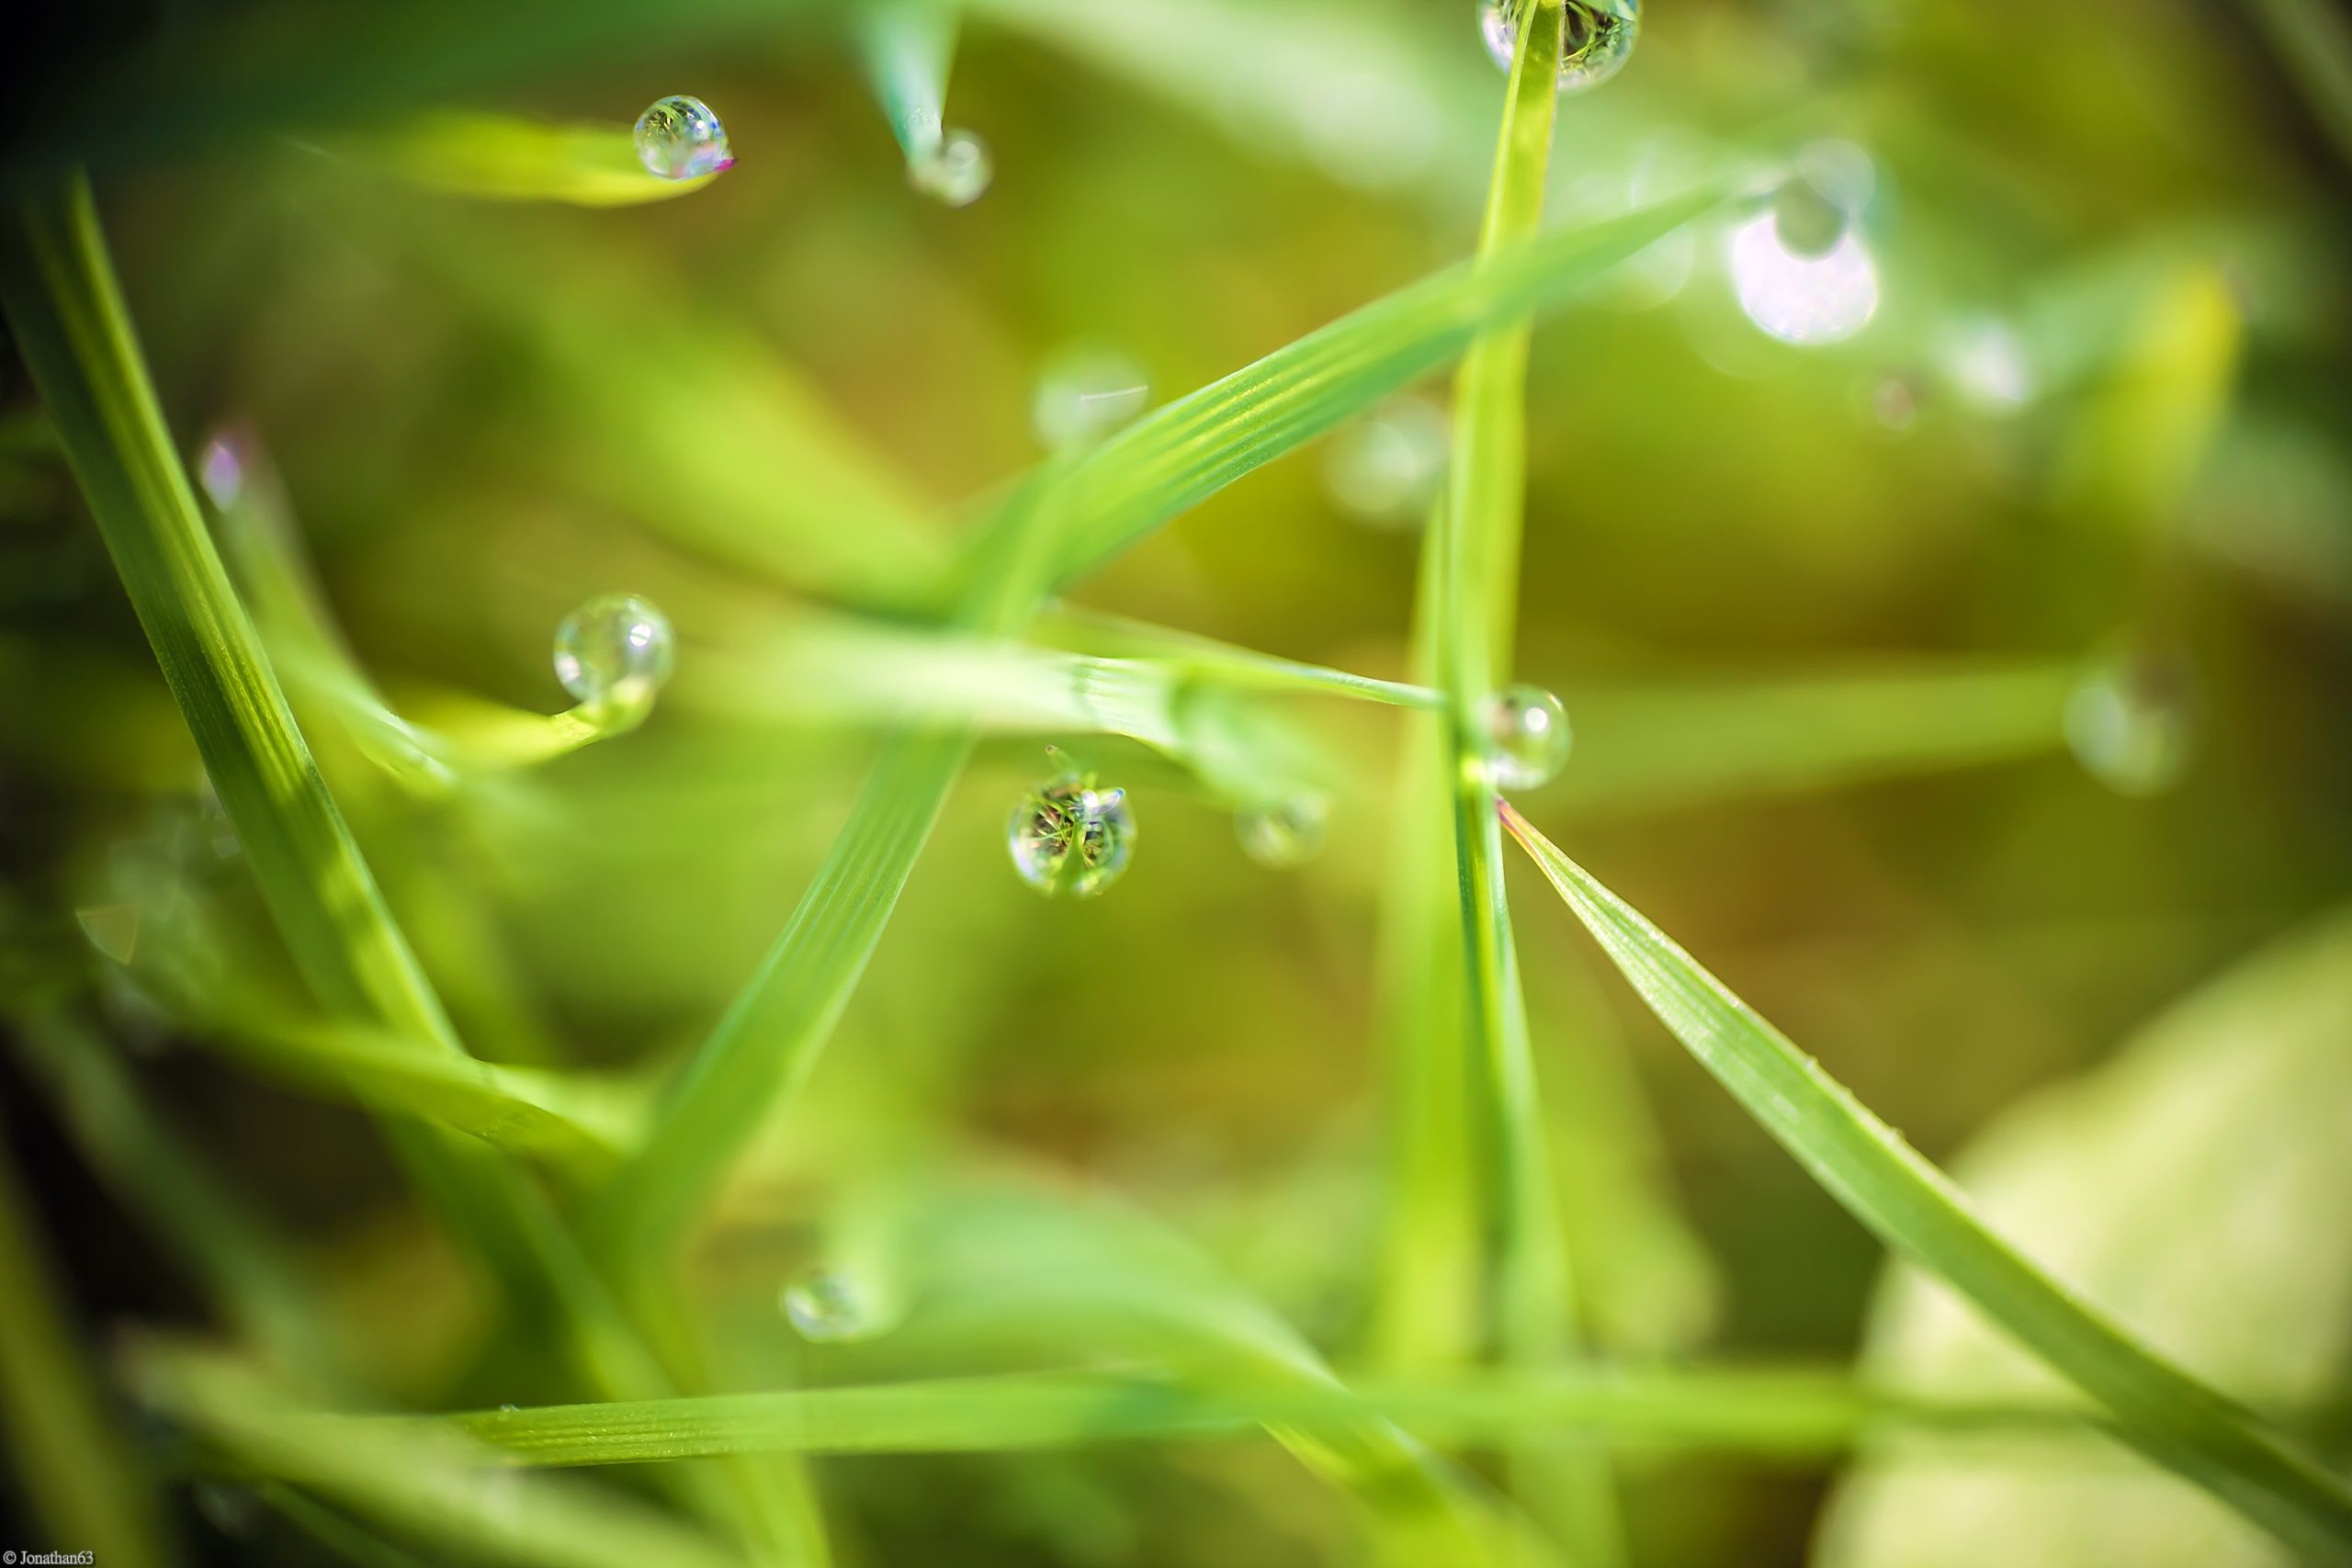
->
0, 1123, 167, 1568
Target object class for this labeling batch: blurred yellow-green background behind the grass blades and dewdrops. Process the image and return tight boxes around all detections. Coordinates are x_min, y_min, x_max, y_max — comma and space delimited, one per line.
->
0, 0, 2352, 1565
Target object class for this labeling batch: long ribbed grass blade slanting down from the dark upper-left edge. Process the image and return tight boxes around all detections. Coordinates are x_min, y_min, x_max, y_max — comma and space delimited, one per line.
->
0, 172, 814, 1568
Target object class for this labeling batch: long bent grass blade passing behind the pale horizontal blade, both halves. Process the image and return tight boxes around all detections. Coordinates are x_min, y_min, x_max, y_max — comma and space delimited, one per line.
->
595, 190, 1717, 1272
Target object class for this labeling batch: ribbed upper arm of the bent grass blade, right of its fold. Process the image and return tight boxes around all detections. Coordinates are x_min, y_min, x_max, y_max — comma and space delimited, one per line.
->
1054, 186, 1722, 581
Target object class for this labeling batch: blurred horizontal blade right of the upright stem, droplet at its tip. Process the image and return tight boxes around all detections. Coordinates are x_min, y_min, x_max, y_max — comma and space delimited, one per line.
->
1550, 660, 2082, 811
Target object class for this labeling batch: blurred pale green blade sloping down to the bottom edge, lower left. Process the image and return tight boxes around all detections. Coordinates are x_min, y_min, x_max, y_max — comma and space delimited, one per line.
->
126, 1342, 743, 1568
